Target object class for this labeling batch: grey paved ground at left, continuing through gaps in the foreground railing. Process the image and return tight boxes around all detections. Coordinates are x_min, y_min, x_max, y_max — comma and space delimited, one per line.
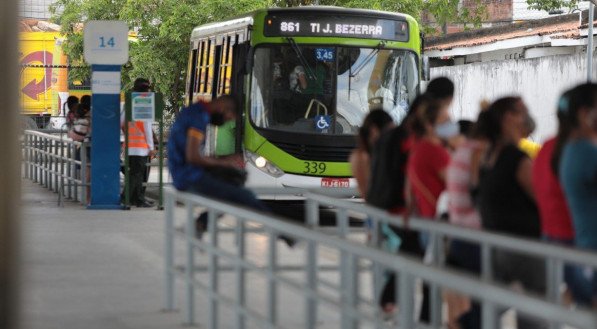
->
21, 179, 524, 329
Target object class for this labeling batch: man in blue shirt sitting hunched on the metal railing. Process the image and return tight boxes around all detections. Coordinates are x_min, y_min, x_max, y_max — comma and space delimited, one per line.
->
168, 95, 294, 245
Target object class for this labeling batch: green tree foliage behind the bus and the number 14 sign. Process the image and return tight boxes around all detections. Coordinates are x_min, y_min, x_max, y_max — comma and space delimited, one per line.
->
51, 0, 480, 110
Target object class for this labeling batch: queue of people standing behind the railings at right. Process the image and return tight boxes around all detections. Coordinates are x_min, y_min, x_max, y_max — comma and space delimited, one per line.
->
350, 78, 597, 328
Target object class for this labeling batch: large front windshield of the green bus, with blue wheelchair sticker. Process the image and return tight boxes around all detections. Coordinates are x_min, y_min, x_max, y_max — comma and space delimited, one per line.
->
251, 43, 419, 135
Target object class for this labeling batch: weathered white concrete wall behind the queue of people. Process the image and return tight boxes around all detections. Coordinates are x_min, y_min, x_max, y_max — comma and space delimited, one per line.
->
431, 54, 597, 142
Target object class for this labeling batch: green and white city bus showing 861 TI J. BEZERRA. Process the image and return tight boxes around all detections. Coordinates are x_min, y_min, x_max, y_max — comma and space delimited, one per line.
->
185, 7, 422, 195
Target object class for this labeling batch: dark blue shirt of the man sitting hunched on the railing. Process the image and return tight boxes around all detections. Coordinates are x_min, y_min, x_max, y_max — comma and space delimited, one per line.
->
168, 103, 209, 190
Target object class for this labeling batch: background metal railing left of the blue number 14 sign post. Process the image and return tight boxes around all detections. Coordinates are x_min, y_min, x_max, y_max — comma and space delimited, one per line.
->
22, 130, 90, 204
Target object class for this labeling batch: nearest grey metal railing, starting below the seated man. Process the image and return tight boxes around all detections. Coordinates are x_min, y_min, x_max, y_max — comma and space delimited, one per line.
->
164, 188, 597, 329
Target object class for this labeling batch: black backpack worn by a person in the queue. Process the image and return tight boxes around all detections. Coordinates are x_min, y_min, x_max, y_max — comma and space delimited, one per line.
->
366, 126, 410, 210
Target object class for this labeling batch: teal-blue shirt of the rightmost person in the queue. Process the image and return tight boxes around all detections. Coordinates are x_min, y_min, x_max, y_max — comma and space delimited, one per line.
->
560, 140, 597, 249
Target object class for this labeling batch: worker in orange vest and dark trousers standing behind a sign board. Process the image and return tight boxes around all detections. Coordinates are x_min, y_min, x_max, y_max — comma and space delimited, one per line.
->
121, 78, 155, 208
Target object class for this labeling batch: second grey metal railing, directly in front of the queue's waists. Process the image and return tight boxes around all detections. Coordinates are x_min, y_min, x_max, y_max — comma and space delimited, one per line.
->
305, 193, 597, 328
